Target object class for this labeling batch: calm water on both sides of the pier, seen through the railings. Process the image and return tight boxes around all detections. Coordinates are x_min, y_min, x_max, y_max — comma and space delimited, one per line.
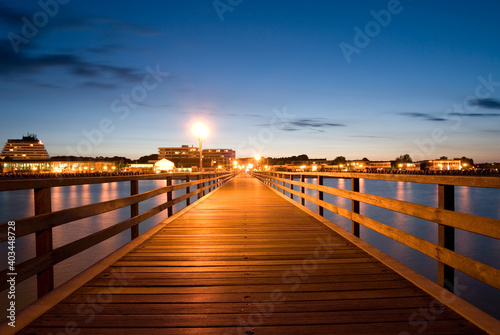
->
0, 179, 500, 319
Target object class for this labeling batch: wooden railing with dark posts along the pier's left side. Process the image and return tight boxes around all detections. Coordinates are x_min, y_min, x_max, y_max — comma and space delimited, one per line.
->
0, 173, 234, 298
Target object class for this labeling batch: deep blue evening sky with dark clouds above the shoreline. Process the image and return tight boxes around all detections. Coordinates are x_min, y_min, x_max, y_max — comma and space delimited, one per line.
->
0, 0, 500, 162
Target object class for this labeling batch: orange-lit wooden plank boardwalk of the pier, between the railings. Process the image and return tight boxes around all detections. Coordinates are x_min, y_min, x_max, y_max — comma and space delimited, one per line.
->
20, 175, 483, 335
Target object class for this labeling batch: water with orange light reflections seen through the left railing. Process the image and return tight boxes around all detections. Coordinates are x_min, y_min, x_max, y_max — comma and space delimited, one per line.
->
0, 180, 188, 316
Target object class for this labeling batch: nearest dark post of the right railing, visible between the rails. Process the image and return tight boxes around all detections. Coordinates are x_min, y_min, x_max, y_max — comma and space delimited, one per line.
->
438, 185, 455, 292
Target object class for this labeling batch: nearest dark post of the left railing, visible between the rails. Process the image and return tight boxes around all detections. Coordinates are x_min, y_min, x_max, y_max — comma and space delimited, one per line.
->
35, 187, 54, 299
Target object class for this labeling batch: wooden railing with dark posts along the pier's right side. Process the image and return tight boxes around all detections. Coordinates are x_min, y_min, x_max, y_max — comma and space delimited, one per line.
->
254, 172, 500, 291
